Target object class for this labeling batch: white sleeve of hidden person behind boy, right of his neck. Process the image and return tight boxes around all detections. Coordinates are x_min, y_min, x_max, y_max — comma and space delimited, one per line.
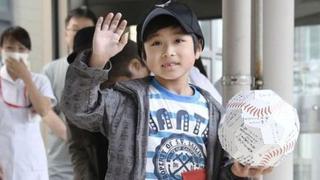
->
189, 67, 222, 104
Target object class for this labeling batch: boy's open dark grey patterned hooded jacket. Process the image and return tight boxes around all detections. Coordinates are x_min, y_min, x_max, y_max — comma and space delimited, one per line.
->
62, 52, 246, 180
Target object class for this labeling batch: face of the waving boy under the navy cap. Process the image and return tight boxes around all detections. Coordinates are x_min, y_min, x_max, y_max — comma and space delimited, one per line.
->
144, 27, 201, 81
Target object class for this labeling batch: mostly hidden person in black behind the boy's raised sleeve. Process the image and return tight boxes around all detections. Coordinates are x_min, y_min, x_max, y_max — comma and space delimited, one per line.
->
66, 26, 104, 180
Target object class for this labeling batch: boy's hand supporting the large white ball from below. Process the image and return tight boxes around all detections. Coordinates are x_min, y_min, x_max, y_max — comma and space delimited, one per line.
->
231, 161, 272, 177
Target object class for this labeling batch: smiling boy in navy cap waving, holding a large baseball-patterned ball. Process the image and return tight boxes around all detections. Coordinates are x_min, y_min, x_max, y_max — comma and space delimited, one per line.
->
62, 1, 272, 180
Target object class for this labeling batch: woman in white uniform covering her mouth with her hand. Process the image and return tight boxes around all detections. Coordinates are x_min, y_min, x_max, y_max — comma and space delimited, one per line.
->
0, 26, 63, 180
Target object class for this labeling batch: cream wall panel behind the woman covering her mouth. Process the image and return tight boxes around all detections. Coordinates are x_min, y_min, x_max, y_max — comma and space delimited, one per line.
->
12, 0, 52, 72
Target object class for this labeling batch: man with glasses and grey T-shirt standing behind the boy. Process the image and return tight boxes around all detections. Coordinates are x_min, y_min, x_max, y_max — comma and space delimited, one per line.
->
43, 7, 97, 180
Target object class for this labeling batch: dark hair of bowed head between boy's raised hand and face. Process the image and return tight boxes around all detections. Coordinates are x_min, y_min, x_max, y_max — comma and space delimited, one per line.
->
109, 40, 144, 79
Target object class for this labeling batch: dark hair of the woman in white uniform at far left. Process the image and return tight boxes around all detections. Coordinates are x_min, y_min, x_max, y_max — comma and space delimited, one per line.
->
0, 26, 31, 50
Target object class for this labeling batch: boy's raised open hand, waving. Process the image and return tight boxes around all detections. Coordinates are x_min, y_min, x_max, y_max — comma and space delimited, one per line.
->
89, 13, 128, 68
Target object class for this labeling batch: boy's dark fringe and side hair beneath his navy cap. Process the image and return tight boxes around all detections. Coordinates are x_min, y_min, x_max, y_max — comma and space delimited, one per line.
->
138, 15, 201, 59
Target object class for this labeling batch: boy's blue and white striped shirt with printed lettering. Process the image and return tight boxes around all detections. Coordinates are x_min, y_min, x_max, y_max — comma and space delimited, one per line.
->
146, 79, 209, 180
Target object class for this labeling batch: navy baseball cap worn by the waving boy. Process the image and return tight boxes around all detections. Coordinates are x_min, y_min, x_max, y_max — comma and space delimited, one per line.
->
137, 0, 204, 57
